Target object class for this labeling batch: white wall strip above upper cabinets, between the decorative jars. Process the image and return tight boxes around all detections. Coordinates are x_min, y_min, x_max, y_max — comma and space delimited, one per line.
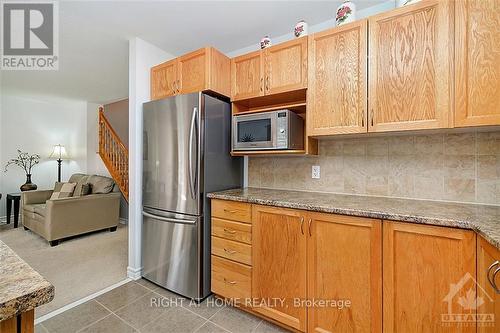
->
227, 0, 396, 58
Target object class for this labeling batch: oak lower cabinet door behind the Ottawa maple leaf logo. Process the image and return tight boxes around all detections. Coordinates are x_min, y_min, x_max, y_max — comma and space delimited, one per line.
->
383, 221, 476, 333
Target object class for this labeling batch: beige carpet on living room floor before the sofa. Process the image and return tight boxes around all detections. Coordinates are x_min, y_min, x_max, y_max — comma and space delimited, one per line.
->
0, 223, 128, 318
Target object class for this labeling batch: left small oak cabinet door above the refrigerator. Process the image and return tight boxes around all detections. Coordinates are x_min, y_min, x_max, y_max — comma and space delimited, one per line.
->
150, 59, 177, 100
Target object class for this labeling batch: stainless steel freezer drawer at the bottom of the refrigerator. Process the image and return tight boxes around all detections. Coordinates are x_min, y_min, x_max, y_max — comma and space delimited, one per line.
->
142, 211, 206, 299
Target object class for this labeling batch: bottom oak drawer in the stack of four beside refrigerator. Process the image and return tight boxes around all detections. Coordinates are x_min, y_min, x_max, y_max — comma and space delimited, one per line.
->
212, 256, 252, 299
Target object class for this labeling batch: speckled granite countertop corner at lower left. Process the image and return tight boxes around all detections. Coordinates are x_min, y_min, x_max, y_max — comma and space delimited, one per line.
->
0, 241, 54, 321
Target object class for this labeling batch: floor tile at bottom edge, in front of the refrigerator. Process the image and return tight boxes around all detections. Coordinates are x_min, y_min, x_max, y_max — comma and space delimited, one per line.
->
141, 307, 206, 333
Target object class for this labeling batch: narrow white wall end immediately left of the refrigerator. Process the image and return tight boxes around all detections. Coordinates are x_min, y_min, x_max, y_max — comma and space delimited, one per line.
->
127, 38, 174, 279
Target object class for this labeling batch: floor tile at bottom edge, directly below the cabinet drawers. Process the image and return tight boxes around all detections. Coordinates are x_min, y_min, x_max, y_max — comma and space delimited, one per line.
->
210, 306, 261, 333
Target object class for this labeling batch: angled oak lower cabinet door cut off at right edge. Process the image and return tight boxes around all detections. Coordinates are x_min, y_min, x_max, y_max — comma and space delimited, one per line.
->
477, 237, 500, 333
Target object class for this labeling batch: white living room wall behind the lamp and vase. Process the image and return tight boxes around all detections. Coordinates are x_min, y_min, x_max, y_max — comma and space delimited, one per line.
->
0, 91, 87, 216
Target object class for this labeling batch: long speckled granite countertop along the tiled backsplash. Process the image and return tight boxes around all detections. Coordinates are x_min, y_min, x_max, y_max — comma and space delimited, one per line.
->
208, 187, 500, 249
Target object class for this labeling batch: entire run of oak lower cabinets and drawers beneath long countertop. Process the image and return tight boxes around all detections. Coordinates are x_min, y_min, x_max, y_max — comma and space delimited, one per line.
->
212, 200, 492, 333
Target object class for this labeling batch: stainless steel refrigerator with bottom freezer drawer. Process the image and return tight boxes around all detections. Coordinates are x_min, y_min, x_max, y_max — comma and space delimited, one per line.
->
142, 93, 243, 299
